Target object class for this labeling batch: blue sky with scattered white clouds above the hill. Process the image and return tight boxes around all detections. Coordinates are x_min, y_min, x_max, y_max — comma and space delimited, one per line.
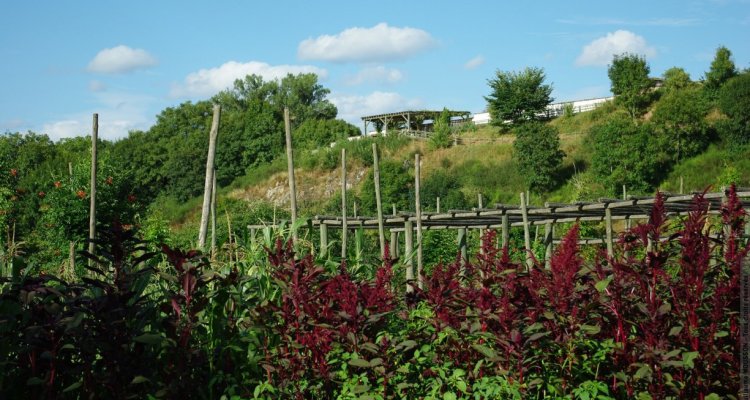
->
0, 0, 750, 140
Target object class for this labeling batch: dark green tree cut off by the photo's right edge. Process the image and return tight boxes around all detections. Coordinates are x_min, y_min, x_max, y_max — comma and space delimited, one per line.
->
719, 72, 750, 146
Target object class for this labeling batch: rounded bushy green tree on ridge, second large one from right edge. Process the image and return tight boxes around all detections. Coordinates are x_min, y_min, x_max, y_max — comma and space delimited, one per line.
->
652, 88, 710, 161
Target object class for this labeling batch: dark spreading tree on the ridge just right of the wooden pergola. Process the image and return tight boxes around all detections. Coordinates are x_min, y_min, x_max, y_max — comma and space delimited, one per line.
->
484, 67, 553, 126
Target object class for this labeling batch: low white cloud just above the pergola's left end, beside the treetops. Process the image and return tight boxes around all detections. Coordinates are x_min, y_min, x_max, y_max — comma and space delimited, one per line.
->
329, 92, 422, 126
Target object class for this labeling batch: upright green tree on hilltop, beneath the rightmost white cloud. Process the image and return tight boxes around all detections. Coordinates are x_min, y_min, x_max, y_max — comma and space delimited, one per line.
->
607, 53, 651, 119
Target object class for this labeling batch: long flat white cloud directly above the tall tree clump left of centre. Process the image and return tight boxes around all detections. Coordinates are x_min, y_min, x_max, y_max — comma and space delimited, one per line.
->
170, 61, 328, 98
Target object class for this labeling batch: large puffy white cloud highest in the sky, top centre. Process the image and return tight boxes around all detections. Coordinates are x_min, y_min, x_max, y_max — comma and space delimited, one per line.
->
297, 22, 437, 62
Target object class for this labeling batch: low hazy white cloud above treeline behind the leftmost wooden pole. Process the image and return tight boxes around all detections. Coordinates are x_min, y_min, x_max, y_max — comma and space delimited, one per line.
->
40, 92, 155, 140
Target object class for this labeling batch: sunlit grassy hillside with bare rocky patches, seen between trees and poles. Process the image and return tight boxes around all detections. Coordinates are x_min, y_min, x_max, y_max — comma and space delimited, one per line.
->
164, 101, 750, 234
